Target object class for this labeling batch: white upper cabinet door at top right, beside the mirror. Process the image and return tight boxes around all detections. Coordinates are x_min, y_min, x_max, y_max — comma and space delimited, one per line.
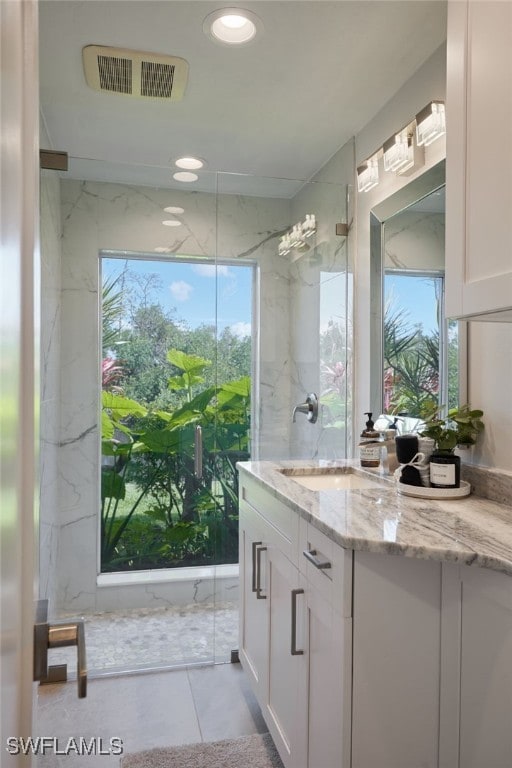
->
464, 0, 512, 312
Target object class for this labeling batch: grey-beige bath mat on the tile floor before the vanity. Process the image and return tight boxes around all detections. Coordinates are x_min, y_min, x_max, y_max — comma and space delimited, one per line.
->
121, 733, 283, 768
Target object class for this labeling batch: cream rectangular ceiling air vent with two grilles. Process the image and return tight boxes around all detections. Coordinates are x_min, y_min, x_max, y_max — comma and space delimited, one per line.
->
82, 45, 188, 101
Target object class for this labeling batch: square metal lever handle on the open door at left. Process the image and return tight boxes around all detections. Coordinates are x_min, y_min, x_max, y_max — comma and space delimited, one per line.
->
34, 600, 87, 699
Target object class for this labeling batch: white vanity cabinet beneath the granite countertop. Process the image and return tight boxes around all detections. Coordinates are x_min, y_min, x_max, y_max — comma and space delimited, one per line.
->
239, 472, 512, 768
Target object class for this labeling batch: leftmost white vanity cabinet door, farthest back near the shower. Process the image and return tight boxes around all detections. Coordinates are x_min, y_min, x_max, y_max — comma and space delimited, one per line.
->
238, 506, 268, 702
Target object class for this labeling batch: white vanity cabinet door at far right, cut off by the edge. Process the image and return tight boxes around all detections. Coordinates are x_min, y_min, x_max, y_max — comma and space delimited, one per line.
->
459, 568, 512, 768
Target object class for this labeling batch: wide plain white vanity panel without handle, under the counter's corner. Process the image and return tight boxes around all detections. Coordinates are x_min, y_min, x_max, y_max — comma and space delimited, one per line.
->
352, 552, 442, 768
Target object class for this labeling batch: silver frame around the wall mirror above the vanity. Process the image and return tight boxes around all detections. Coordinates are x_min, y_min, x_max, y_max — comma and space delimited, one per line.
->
370, 159, 467, 424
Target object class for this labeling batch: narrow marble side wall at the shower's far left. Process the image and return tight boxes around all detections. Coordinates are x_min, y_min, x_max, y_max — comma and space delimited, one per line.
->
39, 171, 61, 610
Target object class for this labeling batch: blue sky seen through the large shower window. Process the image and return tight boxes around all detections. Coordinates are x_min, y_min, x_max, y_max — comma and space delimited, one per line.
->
102, 258, 253, 336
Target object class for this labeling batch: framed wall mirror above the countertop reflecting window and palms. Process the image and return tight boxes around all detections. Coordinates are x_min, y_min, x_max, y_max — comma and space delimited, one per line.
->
370, 160, 465, 426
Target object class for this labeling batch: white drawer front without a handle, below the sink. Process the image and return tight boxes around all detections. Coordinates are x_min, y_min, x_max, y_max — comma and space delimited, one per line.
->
239, 478, 299, 563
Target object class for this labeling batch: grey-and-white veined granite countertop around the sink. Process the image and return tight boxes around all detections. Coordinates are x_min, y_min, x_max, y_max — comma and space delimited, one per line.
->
237, 460, 512, 576
